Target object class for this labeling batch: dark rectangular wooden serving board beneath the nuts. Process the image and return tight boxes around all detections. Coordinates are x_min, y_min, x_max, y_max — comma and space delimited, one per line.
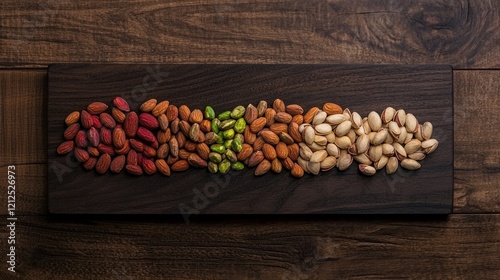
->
47, 64, 453, 214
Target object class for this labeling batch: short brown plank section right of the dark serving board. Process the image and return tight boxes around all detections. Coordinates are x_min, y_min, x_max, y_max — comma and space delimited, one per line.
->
453, 71, 500, 213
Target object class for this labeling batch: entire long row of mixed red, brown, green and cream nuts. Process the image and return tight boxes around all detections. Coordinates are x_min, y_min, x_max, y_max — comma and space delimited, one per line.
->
57, 97, 438, 177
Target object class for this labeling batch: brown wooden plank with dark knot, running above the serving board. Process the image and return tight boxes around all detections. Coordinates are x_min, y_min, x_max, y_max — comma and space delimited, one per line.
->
0, 0, 500, 68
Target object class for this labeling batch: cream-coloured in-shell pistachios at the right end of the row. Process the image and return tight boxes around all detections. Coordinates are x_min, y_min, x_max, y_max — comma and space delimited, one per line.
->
298, 107, 438, 176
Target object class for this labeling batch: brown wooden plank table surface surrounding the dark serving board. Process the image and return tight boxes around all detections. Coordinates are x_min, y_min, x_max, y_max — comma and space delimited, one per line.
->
0, 0, 500, 279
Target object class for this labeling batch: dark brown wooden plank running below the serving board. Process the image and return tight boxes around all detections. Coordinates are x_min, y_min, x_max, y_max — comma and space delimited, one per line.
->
0, 215, 500, 280
